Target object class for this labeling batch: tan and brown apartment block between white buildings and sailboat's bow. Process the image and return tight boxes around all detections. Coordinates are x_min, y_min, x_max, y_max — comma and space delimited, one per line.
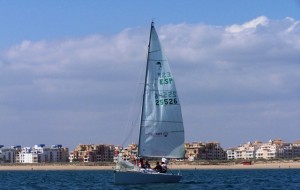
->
69, 144, 115, 162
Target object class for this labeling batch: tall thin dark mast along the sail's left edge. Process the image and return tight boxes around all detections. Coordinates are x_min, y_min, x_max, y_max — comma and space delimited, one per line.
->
138, 21, 154, 157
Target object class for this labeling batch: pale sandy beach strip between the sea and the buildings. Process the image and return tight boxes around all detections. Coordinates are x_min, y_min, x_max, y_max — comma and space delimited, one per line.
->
0, 162, 300, 171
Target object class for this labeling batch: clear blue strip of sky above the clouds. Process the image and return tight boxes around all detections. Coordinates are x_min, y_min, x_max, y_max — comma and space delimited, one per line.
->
0, 0, 300, 49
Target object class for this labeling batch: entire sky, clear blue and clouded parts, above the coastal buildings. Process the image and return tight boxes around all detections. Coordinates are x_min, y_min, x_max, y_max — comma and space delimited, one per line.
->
0, 0, 300, 148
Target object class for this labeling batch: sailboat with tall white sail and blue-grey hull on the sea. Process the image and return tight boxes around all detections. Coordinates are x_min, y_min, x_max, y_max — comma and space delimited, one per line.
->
114, 22, 185, 184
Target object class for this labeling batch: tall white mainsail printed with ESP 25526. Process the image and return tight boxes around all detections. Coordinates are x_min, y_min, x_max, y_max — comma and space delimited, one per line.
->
138, 22, 185, 158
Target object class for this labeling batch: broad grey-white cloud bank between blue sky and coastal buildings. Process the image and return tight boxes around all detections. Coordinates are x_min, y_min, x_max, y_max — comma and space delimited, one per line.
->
0, 16, 300, 147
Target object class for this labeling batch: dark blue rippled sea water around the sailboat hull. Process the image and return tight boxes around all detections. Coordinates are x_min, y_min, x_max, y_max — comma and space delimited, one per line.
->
0, 169, 300, 190
